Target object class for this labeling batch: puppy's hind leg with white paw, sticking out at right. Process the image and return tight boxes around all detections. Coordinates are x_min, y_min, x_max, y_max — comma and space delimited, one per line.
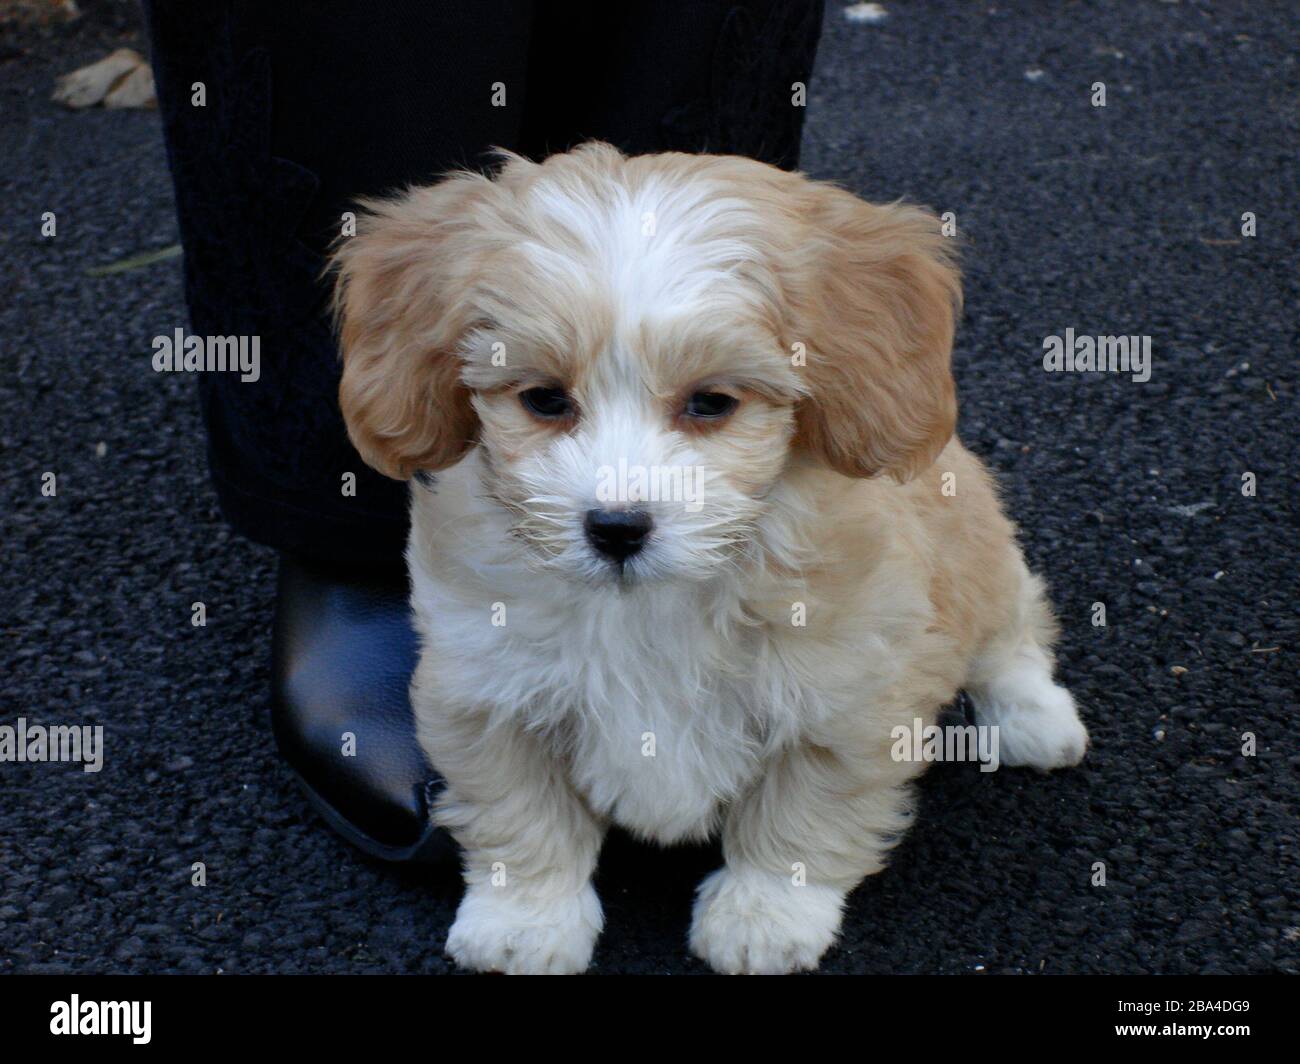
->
966, 567, 1088, 770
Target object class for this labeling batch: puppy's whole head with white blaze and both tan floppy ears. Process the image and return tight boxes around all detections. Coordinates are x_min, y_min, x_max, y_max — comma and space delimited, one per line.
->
335, 144, 959, 583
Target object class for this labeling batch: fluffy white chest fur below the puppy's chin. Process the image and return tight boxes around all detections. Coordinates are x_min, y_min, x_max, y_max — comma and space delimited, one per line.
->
416, 551, 792, 842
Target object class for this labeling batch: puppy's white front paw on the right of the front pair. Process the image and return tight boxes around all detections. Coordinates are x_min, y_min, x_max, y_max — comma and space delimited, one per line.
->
690, 868, 844, 976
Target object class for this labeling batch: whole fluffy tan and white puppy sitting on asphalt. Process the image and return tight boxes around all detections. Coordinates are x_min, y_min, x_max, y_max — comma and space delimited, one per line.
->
334, 143, 1087, 973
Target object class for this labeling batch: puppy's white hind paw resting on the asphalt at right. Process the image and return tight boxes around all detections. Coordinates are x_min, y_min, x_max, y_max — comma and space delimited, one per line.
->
971, 672, 1088, 771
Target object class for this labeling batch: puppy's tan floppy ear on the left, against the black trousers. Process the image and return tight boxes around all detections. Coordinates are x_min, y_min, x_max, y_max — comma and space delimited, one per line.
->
332, 173, 491, 480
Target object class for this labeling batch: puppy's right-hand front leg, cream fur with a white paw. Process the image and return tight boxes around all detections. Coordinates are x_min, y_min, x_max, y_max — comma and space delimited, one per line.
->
690, 748, 913, 974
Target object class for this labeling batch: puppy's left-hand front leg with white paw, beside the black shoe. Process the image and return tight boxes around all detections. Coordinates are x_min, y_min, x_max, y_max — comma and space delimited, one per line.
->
417, 698, 605, 974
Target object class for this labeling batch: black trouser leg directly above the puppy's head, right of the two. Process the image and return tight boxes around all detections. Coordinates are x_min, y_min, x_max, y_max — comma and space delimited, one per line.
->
523, 0, 823, 169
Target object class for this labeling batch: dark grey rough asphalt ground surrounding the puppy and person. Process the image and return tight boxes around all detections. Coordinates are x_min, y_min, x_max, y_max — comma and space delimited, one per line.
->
0, 0, 1300, 973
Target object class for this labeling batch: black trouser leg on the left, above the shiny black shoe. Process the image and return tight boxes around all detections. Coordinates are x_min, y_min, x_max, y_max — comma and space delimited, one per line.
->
147, 0, 533, 562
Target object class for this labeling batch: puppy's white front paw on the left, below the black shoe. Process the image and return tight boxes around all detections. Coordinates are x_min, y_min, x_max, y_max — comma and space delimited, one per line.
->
447, 883, 605, 976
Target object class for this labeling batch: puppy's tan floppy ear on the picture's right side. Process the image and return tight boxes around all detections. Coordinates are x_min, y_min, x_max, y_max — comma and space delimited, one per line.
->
797, 185, 962, 483
